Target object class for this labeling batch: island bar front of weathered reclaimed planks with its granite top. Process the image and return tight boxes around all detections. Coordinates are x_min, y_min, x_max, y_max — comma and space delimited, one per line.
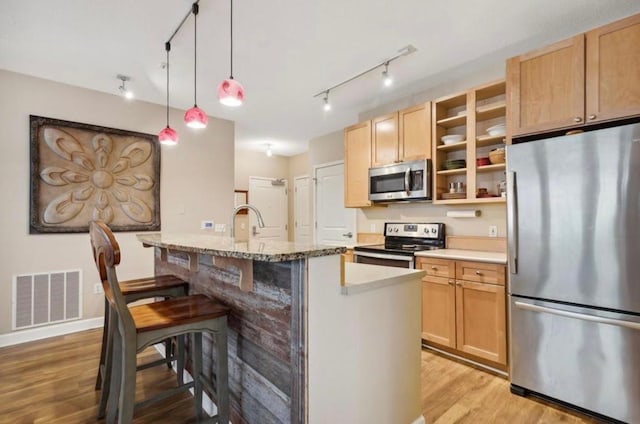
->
137, 233, 345, 424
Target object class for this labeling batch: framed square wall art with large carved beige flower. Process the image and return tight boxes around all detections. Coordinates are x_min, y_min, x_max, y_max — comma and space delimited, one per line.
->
29, 115, 160, 234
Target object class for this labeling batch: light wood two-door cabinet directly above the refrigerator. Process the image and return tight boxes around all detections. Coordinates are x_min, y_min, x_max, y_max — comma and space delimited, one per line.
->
507, 15, 640, 137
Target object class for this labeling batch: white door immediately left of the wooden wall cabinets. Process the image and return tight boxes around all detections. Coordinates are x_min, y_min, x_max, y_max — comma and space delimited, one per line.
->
314, 162, 356, 246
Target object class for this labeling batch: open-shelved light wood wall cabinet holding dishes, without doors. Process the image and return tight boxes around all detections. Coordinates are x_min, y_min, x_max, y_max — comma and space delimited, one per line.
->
432, 80, 506, 204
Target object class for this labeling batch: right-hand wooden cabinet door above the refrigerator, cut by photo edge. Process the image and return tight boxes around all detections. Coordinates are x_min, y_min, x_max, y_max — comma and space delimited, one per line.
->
586, 15, 640, 122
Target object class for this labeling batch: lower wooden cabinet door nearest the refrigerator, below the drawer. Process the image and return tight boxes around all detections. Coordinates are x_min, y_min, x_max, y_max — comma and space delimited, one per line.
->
455, 280, 507, 364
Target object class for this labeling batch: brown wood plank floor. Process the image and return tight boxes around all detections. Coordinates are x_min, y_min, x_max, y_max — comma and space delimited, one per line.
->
0, 330, 597, 424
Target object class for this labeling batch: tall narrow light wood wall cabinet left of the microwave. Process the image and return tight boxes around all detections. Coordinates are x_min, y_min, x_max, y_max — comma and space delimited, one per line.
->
344, 121, 371, 208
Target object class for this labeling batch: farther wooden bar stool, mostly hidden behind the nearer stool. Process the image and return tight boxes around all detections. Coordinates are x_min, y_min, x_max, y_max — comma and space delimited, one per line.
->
95, 275, 189, 390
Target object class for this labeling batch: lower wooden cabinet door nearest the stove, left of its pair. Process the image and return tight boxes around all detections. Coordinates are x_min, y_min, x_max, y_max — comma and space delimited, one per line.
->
422, 277, 456, 348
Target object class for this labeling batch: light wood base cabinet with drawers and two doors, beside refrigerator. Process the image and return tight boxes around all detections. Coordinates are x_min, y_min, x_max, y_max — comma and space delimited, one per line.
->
418, 258, 507, 366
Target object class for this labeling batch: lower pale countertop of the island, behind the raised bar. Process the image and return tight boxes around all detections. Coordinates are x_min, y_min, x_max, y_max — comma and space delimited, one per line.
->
340, 262, 426, 295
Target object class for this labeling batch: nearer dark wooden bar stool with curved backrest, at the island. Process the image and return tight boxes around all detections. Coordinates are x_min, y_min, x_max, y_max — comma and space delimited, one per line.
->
89, 221, 229, 424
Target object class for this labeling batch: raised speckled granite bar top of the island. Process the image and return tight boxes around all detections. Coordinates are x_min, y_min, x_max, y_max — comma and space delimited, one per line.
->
136, 233, 346, 262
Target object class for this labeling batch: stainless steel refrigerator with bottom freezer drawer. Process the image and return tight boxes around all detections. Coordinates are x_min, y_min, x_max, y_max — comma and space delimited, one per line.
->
507, 124, 640, 423
